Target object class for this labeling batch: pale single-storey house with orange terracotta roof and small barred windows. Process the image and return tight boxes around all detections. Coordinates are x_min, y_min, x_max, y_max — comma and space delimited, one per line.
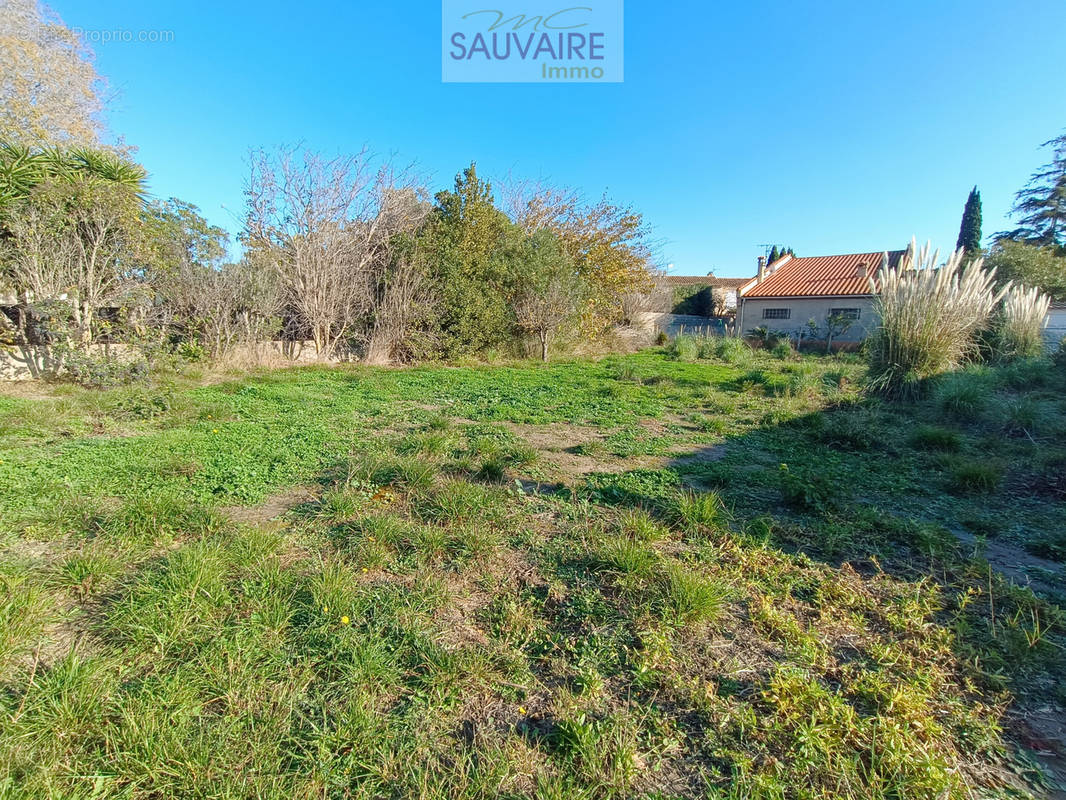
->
737, 250, 907, 342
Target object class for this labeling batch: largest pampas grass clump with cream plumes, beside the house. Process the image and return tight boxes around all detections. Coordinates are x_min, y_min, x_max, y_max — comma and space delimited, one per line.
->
868, 240, 1001, 397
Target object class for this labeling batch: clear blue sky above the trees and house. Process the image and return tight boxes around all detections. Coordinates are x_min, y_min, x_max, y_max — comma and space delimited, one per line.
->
51, 0, 1066, 275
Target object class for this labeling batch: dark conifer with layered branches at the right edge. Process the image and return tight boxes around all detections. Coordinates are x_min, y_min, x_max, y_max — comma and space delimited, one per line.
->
996, 133, 1066, 251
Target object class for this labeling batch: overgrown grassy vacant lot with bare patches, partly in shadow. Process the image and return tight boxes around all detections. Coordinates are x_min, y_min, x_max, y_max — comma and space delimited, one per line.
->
0, 350, 1066, 799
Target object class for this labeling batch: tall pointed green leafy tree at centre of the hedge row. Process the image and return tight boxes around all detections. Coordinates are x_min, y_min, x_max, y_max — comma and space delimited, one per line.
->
422, 163, 521, 358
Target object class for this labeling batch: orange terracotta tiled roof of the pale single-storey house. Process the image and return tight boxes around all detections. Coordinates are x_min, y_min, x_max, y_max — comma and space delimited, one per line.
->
743, 250, 906, 298
